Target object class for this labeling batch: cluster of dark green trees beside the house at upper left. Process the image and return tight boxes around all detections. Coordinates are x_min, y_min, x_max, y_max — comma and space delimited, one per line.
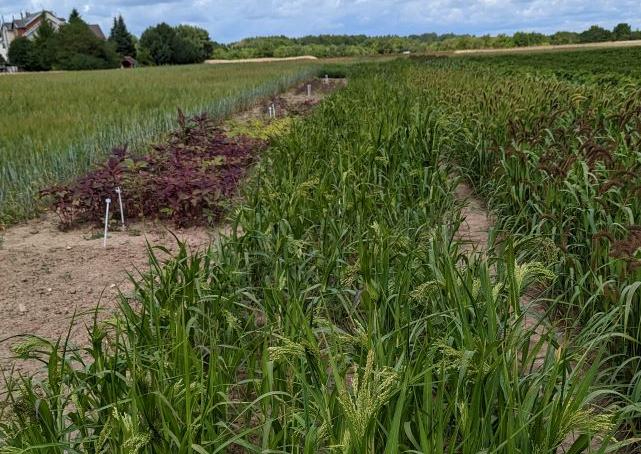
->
8, 9, 215, 71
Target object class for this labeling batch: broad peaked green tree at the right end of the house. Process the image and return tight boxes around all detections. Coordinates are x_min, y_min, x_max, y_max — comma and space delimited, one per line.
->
56, 10, 120, 70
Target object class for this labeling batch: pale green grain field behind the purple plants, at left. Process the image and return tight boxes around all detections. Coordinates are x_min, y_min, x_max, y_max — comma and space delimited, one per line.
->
0, 63, 313, 223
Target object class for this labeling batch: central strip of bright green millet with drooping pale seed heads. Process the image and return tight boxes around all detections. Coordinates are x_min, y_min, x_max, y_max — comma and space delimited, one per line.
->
0, 64, 620, 454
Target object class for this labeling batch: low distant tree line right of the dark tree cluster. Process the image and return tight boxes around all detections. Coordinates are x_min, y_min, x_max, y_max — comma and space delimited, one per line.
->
213, 23, 641, 58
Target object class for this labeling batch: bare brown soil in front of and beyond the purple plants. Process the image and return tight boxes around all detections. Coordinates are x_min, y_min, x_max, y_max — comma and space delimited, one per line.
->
0, 79, 346, 384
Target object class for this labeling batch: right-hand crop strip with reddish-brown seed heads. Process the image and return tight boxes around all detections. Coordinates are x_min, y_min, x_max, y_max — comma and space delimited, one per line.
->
411, 54, 641, 436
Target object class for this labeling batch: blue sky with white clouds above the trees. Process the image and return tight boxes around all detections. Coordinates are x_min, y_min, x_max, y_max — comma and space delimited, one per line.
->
0, 0, 641, 43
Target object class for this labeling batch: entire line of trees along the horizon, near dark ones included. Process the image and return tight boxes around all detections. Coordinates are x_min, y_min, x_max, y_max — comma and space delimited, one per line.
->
6, 15, 641, 71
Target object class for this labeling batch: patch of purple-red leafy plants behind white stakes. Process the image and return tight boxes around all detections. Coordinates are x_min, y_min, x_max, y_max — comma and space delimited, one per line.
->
41, 111, 266, 228
